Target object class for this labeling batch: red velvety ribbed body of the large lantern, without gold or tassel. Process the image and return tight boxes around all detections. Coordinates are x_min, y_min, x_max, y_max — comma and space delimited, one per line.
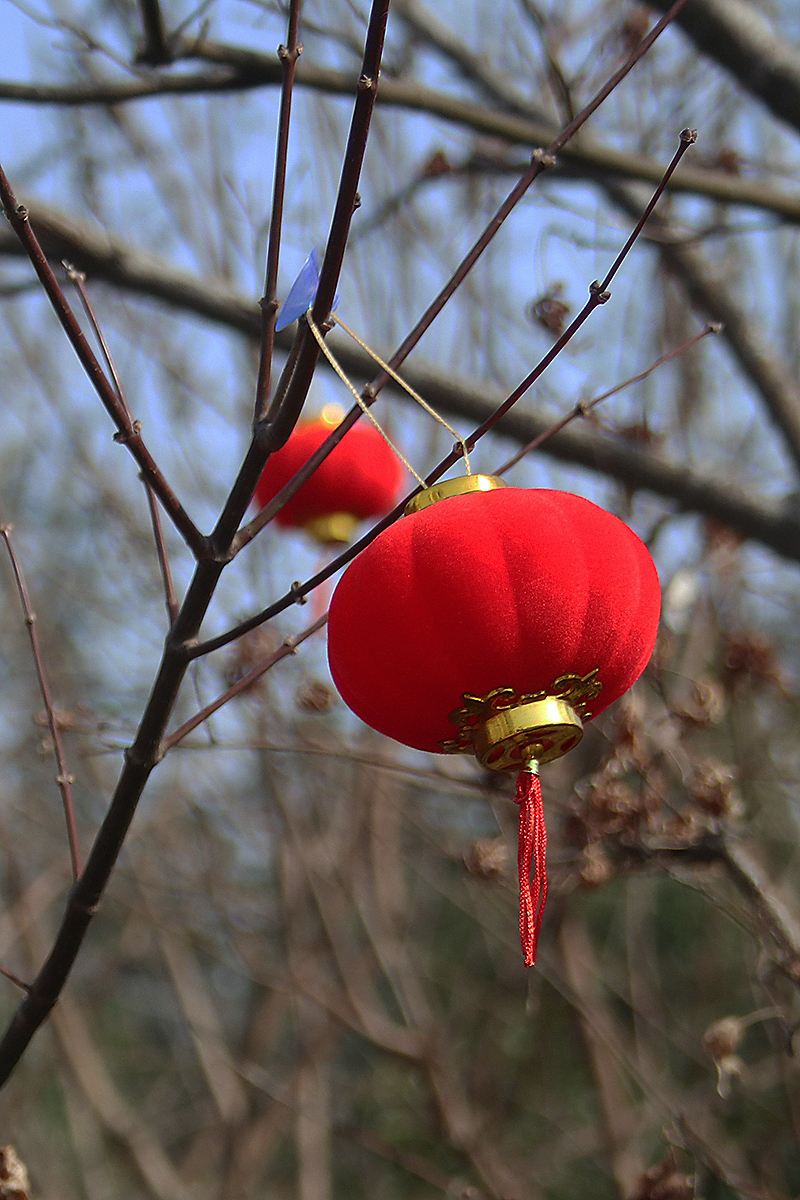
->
329, 488, 661, 751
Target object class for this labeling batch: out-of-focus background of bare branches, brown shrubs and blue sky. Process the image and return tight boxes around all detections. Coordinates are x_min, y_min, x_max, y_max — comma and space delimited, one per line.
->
0, 0, 800, 1200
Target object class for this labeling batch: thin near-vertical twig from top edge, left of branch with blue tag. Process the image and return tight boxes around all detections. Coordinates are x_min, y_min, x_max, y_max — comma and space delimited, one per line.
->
254, 0, 302, 425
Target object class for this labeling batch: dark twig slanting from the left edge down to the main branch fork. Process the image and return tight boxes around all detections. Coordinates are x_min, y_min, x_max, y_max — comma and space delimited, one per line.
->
0, 167, 207, 559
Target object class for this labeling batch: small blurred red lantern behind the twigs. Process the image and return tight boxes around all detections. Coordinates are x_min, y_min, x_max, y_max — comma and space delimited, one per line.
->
255, 404, 402, 542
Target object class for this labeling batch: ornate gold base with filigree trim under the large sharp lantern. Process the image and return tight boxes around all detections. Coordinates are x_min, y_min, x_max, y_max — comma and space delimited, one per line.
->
439, 667, 602, 770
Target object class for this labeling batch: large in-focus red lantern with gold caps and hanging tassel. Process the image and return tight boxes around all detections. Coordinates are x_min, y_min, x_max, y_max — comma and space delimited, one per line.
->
329, 475, 660, 966
